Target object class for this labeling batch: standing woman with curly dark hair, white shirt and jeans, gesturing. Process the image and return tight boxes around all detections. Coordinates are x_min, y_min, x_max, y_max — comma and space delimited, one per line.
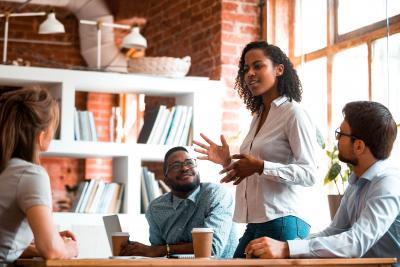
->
194, 41, 317, 258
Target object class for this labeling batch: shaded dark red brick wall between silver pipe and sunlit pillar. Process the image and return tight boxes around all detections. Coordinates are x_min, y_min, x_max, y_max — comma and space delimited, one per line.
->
113, 0, 221, 79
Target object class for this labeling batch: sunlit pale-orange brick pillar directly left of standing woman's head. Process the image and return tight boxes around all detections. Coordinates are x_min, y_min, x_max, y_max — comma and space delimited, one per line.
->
221, 0, 261, 152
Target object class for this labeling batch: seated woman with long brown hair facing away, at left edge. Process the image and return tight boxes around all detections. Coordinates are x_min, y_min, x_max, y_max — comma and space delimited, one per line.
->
0, 87, 78, 262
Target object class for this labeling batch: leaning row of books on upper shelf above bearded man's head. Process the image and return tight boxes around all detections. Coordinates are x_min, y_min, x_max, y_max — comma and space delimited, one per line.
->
138, 105, 193, 146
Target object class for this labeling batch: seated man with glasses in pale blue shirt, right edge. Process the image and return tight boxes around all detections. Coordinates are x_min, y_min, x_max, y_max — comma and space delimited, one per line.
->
246, 101, 400, 260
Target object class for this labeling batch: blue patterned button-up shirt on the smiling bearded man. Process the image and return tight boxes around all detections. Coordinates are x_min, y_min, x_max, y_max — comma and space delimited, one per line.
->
146, 183, 238, 258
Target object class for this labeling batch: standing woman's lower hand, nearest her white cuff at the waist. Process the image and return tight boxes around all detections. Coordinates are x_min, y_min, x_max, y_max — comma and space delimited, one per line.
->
220, 154, 264, 185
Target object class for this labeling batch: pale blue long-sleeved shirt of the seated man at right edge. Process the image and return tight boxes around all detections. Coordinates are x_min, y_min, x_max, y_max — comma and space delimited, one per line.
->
288, 161, 400, 259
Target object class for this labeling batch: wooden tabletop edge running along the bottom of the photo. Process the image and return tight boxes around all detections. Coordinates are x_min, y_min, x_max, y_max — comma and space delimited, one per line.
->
17, 258, 397, 267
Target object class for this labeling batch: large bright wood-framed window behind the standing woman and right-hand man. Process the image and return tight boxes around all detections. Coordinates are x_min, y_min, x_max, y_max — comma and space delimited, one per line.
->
264, 0, 400, 231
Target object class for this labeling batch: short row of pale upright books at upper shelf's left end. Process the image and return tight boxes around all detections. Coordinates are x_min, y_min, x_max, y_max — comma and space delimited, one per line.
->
74, 109, 97, 141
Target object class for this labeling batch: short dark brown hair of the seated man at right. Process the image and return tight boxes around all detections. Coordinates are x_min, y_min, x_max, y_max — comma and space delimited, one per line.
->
343, 101, 397, 159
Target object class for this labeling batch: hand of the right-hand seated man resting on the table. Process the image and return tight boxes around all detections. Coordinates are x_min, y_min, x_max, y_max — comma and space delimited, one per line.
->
245, 237, 289, 259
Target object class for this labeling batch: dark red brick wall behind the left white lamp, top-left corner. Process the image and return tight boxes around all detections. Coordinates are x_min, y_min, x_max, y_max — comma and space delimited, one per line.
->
0, 3, 86, 68
